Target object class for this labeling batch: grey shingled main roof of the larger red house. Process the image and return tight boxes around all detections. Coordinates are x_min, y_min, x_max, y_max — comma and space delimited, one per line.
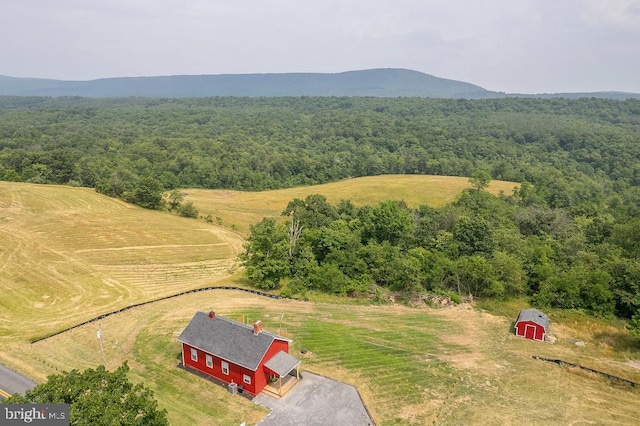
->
178, 312, 290, 371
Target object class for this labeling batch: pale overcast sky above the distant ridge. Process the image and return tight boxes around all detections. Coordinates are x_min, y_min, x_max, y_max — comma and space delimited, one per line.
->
0, 0, 640, 93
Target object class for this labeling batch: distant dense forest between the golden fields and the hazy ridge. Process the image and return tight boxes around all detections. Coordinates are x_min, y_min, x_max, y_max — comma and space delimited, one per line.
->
0, 97, 640, 198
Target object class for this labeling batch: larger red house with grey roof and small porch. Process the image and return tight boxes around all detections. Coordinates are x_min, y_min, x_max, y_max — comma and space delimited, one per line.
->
178, 312, 300, 396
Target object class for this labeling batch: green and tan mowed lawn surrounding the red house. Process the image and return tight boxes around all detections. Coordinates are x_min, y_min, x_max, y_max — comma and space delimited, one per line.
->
11, 290, 640, 425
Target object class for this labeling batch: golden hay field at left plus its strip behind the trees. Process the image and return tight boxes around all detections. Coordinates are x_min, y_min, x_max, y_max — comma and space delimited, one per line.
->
0, 176, 504, 340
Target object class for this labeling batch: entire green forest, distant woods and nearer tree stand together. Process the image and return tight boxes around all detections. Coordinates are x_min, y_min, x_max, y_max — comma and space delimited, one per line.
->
0, 97, 640, 326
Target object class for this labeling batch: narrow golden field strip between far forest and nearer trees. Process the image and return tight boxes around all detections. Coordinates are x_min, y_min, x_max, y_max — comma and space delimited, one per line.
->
184, 175, 518, 234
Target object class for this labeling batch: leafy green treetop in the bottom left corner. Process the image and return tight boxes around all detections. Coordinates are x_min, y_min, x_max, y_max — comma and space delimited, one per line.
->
4, 361, 168, 426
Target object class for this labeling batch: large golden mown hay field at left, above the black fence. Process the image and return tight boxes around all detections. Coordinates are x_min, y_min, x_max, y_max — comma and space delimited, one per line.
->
0, 182, 242, 341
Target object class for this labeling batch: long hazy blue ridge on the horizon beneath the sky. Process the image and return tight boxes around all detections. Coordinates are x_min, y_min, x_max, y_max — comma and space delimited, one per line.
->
0, 68, 640, 99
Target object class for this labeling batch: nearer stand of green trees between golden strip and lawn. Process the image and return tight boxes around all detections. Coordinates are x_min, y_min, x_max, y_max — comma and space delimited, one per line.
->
241, 185, 640, 319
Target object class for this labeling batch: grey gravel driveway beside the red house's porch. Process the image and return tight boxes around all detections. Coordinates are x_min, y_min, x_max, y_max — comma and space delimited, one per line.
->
253, 372, 373, 426
